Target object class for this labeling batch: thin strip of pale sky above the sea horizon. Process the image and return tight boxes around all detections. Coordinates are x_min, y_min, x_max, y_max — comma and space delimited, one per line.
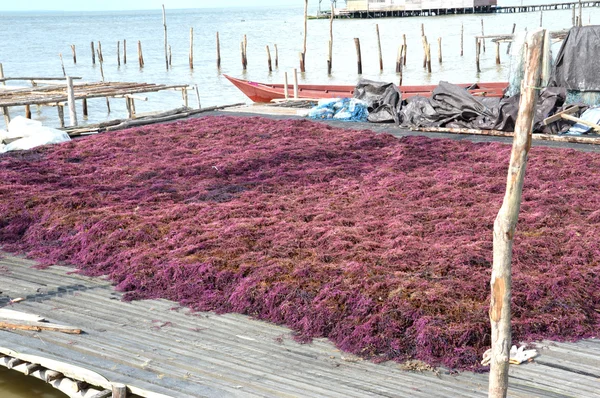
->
0, 0, 310, 11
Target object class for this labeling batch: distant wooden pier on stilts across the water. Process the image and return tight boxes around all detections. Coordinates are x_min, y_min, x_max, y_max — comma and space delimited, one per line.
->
328, 1, 600, 18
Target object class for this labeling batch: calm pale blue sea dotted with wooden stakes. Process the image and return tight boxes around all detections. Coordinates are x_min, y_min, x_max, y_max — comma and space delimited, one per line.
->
0, 1, 600, 125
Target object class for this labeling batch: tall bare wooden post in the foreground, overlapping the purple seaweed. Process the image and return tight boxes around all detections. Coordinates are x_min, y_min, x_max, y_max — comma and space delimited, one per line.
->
488, 30, 544, 398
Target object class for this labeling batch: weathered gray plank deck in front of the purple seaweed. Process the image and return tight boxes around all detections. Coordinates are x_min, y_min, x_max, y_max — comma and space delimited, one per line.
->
0, 255, 600, 398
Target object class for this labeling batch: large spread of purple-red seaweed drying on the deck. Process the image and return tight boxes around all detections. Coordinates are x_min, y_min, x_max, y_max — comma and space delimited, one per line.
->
0, 117, 600, 369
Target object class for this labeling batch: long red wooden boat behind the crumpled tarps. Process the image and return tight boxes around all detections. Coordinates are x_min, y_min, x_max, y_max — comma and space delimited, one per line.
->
223, 75, 508, 102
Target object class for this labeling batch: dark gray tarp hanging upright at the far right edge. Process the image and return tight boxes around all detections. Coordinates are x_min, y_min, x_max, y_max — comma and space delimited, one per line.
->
550, 25, 600, 91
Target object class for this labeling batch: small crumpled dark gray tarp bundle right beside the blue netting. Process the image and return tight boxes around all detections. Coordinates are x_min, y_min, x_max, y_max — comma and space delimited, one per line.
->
354, 79, 402, 124
